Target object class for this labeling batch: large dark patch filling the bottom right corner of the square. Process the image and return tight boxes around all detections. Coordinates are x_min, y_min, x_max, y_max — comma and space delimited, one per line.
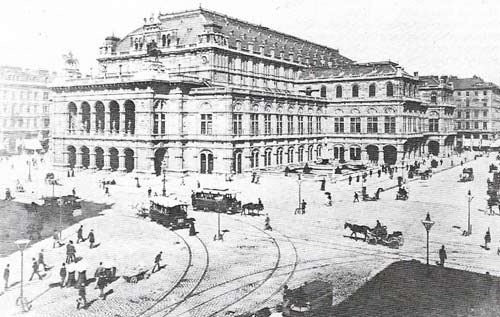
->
331, 261, 500, 316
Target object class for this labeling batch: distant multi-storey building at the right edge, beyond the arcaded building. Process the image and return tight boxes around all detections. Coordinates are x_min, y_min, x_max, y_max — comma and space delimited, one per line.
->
449, 76, 500, 149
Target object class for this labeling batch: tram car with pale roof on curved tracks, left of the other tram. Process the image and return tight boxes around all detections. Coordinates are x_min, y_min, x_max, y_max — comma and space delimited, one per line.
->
149, 196, 192, 230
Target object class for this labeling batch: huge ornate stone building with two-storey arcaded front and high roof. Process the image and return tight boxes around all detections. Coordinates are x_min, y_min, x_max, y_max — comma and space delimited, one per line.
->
48, 8, 458, 175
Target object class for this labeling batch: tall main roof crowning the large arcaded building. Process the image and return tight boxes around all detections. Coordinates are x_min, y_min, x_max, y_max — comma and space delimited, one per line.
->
117, 8, 352, 65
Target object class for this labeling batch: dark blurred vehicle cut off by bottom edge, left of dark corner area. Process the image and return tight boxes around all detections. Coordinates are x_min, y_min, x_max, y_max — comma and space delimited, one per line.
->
283, 280, 333, 317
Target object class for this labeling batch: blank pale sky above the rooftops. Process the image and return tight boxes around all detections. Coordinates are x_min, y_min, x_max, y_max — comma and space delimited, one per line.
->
0, 0, 500, 84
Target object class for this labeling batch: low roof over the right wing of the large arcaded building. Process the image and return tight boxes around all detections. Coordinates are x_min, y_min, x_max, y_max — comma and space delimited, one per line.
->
299, 61, 412, 80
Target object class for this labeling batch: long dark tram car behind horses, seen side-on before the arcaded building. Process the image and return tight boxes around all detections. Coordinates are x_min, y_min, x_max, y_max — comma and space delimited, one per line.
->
191, 188, 241, 213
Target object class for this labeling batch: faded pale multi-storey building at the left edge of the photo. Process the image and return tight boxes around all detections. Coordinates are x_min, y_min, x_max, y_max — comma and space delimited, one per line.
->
0, 66, 55, 153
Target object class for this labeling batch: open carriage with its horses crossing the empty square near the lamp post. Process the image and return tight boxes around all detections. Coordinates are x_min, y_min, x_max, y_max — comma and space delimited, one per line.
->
344, 221, 404, 249
